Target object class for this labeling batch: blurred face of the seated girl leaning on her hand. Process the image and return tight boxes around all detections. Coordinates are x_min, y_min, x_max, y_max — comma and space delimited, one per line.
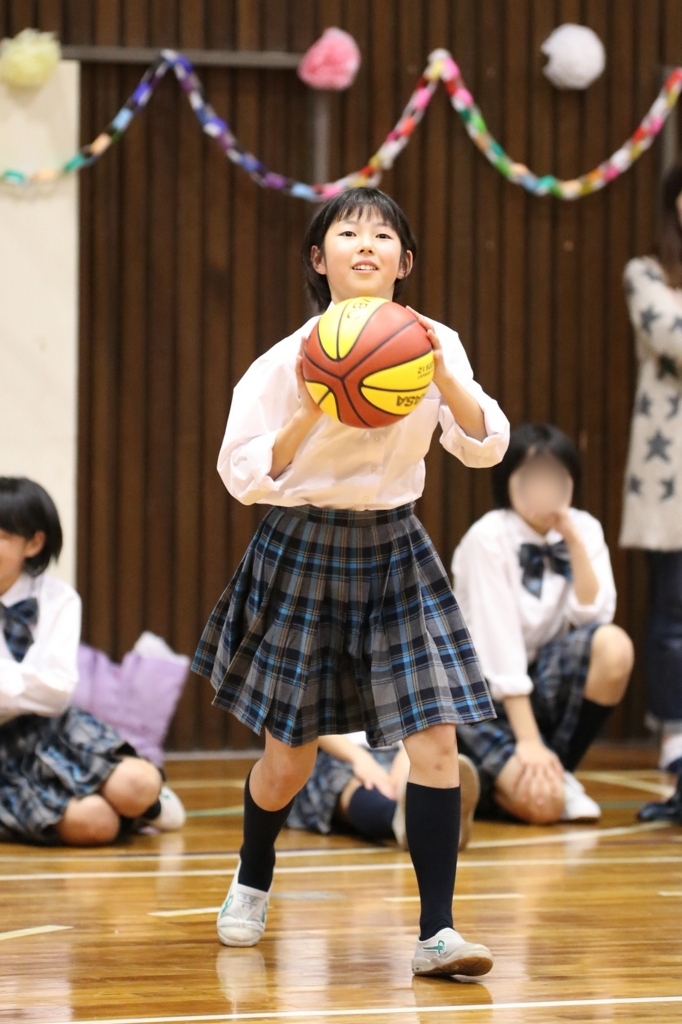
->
509, 454, 573, 534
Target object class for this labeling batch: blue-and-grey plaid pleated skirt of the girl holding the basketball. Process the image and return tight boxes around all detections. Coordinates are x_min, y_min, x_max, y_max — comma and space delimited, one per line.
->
193, 505, 495, 748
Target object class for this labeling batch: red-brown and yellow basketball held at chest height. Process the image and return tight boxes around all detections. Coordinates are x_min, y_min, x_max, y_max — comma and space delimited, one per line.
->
302, 297, 433, 428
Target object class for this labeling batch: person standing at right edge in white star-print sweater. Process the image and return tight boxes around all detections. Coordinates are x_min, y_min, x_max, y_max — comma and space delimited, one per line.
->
621, 157, 682, 771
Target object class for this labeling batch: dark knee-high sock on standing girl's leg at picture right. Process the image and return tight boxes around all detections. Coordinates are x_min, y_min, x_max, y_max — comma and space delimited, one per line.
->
404, 782, 461, 941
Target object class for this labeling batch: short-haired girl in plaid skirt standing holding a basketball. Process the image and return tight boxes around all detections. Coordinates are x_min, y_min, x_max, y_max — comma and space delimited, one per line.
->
195, 188, 509, 975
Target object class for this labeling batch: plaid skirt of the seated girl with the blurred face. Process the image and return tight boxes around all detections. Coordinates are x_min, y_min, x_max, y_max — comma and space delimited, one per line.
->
457, 623, 599, 816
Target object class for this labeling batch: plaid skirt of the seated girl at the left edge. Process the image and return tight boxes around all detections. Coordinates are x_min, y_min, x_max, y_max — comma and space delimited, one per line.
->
0, 708, 135, 846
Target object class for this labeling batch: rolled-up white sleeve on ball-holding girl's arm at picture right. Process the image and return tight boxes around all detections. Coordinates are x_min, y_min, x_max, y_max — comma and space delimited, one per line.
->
437, 325, 509, 469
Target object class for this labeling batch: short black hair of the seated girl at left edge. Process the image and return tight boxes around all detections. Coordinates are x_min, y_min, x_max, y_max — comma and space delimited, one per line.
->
0, 476, 62, 577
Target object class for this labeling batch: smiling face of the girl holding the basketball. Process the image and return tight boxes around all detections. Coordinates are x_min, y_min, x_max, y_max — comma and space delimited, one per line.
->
310, 209, 413, 302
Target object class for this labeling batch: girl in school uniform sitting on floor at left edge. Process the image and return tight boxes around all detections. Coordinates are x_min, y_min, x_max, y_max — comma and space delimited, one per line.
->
0, 477, 184, 846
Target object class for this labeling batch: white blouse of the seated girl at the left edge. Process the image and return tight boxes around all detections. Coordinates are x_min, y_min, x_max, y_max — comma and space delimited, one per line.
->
0, 573, 81, 725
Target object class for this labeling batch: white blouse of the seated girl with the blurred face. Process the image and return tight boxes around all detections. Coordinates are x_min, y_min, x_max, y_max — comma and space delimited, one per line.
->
453, 509, 615, 700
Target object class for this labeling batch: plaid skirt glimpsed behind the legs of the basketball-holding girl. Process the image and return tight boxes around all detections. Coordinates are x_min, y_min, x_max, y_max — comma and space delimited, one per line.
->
287, 746, 400, 836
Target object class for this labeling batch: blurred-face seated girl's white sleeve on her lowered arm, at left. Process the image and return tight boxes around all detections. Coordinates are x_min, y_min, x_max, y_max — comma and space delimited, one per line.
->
452, 526, 532, 700
